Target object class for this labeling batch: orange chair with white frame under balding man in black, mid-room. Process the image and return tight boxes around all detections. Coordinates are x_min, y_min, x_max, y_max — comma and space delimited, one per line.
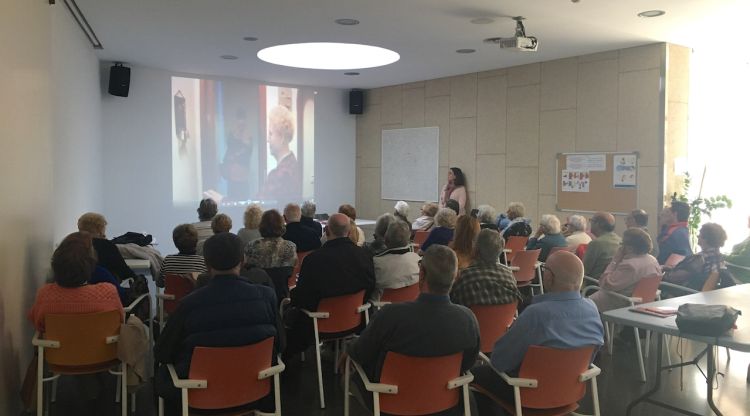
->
302, 290, 370, 409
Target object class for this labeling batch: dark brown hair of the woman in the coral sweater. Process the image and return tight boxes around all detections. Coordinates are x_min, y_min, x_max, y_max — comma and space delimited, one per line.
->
52, 232, 96, 287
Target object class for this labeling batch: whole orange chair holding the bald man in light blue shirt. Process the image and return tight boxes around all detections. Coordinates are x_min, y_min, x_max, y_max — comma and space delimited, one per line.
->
472, 345, 601, 416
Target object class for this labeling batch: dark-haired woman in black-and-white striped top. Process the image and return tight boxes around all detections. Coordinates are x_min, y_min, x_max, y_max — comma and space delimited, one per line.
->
155, 224, 207, 287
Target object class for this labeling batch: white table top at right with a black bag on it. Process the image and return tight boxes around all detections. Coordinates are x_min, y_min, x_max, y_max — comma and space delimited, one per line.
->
602, 284, 750, 352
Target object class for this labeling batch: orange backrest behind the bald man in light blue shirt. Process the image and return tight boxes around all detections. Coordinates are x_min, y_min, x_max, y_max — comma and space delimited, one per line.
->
518, 345, 594, 409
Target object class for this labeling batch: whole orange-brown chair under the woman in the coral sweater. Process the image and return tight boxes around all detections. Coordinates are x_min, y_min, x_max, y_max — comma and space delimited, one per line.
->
31, 310, 128, 416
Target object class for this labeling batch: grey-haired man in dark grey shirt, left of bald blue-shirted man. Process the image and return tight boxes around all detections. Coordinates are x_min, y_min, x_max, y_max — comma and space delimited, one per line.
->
347, 246, 479, 414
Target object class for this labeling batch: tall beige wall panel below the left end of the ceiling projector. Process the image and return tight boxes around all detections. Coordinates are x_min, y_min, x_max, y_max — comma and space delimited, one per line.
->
477, 77, 507, 154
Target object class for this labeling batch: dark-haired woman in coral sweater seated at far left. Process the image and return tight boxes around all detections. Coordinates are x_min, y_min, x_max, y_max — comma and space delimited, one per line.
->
28, 232, 125, 332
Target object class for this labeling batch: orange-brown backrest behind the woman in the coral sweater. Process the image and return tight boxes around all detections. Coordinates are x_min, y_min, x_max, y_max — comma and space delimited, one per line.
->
44, 310, 121, 367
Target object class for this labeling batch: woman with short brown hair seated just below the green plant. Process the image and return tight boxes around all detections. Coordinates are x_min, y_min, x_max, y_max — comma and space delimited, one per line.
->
664, 222, 731, 291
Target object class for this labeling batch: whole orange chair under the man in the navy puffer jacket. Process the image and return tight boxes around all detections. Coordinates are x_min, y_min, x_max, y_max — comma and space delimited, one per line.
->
159, 337, 285, 416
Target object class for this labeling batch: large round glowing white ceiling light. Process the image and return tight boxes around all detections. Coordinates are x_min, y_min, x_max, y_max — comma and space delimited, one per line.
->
258, 42, 401, 70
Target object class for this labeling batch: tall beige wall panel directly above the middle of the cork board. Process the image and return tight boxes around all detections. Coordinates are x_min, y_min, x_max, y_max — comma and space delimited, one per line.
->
576, 60, 618, 151
